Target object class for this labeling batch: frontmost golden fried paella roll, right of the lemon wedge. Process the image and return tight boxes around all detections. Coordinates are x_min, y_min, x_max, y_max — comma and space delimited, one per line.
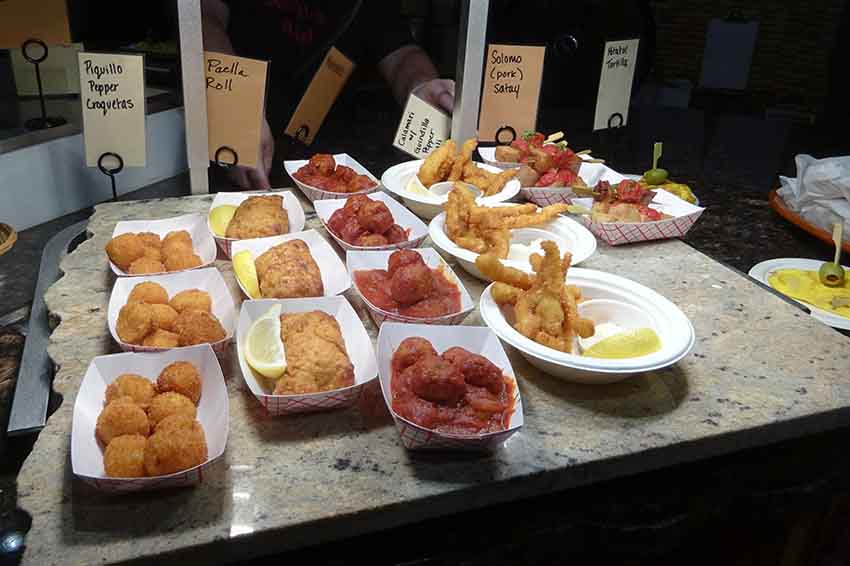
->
274, 311, 354, 395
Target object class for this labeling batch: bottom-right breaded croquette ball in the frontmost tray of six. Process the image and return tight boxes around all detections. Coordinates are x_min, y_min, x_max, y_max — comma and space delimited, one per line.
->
145, 415, 207, 476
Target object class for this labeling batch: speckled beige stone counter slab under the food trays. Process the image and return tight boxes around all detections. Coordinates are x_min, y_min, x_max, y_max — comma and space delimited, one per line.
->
13, 193, 850, 565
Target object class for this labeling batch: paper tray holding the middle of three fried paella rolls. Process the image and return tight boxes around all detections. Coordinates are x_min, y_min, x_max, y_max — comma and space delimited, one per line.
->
227, 229, 351, 299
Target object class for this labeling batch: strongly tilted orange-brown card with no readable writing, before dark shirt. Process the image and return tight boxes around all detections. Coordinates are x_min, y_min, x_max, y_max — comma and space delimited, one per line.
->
285, 47, 355, 145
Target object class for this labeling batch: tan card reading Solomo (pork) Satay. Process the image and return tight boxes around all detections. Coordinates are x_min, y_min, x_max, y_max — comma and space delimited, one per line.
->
478, 44, 546, 141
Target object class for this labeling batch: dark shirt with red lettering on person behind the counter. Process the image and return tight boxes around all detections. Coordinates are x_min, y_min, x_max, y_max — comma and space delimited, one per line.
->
225, 0, 413, 131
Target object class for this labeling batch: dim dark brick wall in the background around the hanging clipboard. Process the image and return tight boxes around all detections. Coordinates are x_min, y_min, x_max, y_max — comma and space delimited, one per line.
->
653, 0, 845, 108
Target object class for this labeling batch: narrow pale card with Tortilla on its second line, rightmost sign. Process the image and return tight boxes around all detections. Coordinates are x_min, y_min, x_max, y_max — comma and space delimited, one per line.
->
593, 39, 639, 130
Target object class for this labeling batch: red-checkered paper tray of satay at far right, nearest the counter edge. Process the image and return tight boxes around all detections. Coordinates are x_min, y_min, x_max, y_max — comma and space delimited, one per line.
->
573, 189, 705, 246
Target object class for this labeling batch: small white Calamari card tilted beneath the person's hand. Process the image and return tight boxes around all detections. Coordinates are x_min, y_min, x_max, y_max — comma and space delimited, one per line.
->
393, 94, 452, 159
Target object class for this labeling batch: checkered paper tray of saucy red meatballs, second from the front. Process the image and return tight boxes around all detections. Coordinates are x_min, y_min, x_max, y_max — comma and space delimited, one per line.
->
345, 248, 475, 328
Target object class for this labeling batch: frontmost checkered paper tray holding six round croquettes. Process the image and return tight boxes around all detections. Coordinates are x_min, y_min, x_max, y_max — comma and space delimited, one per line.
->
71, 344, 230, 493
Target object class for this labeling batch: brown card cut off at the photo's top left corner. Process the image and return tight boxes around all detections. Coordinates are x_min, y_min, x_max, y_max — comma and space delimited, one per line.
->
0, 0, 71, 49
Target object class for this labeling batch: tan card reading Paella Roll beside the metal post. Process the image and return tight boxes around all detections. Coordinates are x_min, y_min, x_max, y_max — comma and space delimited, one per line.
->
204, 51, 269, 167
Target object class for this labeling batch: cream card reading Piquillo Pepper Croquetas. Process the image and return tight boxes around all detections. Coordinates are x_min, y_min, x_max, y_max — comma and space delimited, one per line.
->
77, 53, 145, 167
